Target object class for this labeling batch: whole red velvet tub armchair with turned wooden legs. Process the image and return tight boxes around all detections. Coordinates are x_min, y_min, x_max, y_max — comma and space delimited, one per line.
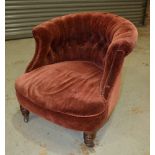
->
15, 12, 137, 147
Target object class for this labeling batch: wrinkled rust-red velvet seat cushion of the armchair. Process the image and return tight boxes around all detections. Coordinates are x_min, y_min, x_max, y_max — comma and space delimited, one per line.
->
15, 61, 105, 116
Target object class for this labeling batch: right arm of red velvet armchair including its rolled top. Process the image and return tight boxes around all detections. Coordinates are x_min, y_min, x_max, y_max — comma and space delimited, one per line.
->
100, 21, 138, 100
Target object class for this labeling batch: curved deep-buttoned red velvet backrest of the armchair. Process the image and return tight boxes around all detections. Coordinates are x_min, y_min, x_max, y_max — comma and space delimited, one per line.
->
28, 12, 137, 72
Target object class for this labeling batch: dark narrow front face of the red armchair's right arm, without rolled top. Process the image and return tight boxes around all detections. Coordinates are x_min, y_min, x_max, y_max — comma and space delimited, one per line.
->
100, 39, 136, 100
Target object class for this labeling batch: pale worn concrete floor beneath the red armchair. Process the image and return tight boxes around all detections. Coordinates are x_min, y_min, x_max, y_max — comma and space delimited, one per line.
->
6, 28, 150, 155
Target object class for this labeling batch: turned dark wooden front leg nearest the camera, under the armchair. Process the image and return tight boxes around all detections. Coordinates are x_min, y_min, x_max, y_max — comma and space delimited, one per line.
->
83, 132, 96, 147
